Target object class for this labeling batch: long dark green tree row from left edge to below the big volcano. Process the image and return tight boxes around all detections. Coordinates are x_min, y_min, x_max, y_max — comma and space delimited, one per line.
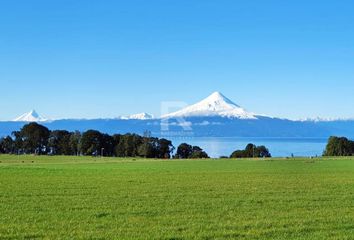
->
0, 123, 209, 159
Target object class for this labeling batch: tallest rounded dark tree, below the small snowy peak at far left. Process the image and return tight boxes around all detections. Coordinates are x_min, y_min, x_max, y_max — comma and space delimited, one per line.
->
15, 123, 50, 155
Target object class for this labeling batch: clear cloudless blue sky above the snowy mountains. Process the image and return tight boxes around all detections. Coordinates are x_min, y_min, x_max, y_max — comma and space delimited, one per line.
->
0, 0, 354, 120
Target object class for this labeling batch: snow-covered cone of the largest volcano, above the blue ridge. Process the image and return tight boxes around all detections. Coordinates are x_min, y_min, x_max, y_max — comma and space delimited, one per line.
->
162, 92, 257, 119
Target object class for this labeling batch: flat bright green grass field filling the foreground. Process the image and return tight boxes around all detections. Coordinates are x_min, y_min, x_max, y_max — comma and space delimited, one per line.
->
0, 156, 354, 240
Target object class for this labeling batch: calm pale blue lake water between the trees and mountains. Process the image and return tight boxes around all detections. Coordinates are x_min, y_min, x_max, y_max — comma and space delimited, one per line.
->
171, 137, 327, 157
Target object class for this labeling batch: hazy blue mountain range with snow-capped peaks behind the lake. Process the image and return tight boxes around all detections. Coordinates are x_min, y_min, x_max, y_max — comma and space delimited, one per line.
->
0, 92, 354, 138
